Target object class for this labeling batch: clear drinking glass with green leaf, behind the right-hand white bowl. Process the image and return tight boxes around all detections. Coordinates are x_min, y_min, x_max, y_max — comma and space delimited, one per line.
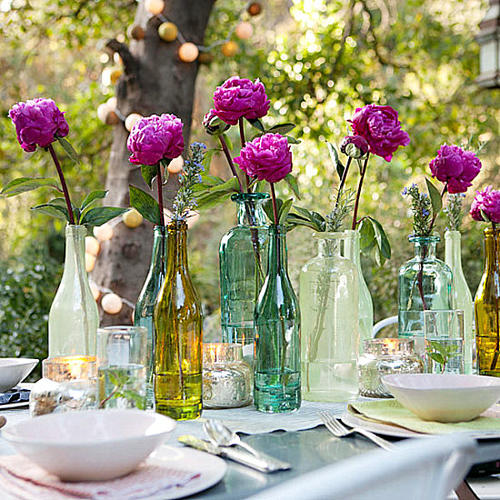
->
423, 309, 464, 373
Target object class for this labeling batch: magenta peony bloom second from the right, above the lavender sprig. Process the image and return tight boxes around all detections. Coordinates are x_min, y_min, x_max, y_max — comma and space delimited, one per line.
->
429, 144, 481, 194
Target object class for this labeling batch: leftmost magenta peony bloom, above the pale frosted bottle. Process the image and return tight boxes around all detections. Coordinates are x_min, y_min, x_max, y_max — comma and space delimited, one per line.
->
9, 99, 69, 152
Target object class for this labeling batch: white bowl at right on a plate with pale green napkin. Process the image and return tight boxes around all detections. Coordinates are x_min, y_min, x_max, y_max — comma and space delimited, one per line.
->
382, 373, 500, 422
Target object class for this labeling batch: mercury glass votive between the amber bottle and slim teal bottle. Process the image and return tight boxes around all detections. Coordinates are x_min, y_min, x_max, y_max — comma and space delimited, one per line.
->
203, 342, 252, 408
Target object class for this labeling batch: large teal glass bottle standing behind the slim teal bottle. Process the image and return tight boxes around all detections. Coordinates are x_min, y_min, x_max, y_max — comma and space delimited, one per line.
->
219, 193, 269, 361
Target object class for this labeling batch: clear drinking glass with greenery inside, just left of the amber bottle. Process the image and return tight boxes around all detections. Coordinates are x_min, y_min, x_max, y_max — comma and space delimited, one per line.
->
97, 326, 147, 410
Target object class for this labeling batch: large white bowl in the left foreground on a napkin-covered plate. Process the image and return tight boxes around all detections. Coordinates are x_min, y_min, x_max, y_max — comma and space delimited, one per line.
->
2, 410, 176, 481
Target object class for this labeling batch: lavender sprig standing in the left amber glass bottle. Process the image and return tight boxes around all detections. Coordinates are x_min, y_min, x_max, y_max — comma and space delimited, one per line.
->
172, 142, 207, 220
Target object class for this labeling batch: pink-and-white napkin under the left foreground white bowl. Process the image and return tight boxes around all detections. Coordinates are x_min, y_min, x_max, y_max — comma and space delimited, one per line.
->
0, 455, 200, 500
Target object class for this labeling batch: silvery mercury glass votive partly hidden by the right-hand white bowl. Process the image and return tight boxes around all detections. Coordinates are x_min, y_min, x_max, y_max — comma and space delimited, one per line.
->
358, 339, 424, 398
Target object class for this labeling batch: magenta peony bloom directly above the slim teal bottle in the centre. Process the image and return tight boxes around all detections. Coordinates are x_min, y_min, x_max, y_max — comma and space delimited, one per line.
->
234, 134, 292, 182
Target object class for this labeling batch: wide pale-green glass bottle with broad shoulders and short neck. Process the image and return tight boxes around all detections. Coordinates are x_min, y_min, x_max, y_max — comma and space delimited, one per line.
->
299, 231, 359, 401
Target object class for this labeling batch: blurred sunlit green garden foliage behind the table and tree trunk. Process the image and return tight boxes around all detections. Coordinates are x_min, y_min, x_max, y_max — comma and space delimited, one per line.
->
0, 0, 500, 358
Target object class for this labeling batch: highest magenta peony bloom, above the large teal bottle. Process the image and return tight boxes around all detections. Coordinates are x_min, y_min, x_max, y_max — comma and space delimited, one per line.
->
214, 76, 270, 125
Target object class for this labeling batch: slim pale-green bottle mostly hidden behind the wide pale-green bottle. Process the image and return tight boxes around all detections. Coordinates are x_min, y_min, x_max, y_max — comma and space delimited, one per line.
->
343, 229, 373, 344
